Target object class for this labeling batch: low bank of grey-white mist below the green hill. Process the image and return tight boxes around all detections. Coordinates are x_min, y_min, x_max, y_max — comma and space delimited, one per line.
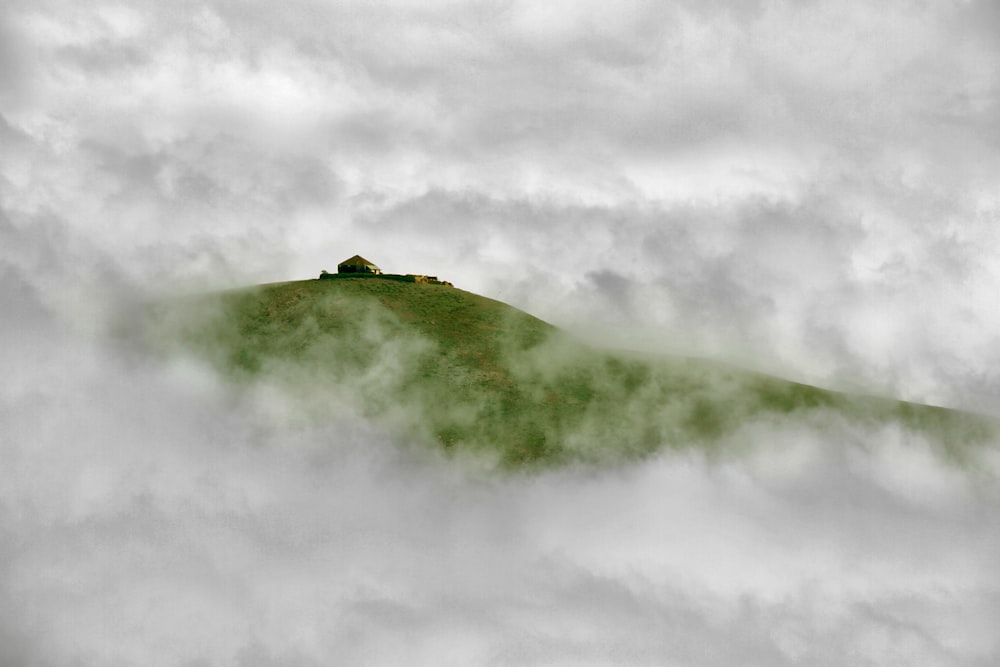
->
0, 274, 1000, 665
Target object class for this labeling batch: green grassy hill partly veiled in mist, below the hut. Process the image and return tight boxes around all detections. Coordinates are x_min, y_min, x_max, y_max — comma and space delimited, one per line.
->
141, 277, 992, 468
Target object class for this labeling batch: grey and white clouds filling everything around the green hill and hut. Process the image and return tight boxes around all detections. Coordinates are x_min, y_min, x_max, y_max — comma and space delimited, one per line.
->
0, 0, 1000, 665
